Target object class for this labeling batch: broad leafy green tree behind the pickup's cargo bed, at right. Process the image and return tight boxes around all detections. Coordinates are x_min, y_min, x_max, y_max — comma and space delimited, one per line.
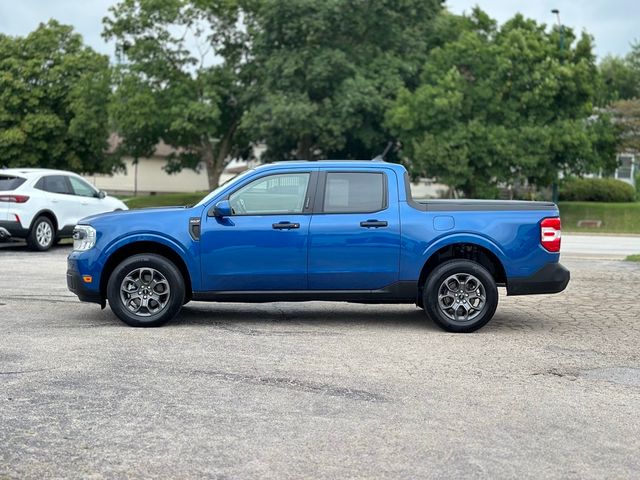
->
387, 8, 615, 197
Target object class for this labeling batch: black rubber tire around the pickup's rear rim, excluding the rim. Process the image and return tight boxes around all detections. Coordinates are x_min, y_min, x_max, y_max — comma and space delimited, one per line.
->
423, 260, 498, 332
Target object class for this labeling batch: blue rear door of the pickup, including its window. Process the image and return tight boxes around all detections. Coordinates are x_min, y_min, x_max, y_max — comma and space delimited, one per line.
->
308, 168, 400, 290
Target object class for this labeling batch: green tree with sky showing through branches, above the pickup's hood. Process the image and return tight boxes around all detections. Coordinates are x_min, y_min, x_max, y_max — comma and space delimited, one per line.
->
104, 0, 248, 188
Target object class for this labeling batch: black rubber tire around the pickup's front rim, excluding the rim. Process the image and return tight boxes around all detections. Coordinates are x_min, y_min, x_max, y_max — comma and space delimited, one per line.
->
107, 254, 185, 327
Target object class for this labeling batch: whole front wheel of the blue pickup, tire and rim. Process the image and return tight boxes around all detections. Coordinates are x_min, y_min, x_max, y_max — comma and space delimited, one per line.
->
107, 253, 185, 327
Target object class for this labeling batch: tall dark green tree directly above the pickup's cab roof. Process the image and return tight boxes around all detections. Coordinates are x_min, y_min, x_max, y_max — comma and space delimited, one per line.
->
242, 0, 441, 161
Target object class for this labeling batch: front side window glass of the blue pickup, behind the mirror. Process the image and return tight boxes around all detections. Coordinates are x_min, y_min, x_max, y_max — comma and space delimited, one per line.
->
229, 173, 311, 215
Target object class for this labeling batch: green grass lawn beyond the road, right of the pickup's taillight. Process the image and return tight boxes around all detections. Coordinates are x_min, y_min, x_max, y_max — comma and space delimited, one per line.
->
558, 202, 640, 234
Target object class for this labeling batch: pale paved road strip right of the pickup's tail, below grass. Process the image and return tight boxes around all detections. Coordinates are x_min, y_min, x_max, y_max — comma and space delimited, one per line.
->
562, 233, 640, 259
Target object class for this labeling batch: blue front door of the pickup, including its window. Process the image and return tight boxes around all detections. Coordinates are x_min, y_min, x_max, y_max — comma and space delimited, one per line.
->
200, 171, 315, 291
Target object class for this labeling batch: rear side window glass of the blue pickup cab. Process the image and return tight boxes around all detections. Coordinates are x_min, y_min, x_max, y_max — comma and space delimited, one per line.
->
323, 172, 386, 213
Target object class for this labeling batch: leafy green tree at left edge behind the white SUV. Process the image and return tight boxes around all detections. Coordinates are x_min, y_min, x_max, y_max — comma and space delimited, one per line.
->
0, 20, 115, 173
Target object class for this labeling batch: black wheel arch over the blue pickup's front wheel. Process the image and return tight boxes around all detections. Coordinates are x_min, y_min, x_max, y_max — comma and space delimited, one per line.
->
100, 240, 193, 302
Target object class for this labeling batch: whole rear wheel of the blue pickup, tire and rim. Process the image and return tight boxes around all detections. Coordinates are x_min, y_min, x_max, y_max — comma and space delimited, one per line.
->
423, 260, 498, 333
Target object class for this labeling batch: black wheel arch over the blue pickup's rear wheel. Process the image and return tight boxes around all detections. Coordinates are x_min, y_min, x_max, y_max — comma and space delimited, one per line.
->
416, 241, 507, 305
